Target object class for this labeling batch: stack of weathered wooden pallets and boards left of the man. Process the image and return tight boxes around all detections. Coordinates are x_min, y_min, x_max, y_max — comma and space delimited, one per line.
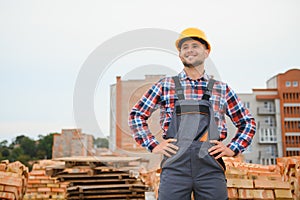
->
52, 157, 148, 200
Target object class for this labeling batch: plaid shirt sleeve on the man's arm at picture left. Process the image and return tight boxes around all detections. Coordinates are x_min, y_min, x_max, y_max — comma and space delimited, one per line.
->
128, 81, 162, 152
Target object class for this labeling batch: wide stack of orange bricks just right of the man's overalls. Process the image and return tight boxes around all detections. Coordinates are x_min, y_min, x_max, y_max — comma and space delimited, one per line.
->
224, 158, 297, 200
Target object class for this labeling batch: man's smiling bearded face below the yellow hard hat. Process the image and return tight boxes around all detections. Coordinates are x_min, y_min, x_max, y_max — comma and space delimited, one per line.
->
179, 39, 209, 67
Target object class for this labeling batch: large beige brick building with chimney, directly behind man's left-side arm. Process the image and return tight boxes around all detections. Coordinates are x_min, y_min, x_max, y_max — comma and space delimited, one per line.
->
109, 75, 164, 152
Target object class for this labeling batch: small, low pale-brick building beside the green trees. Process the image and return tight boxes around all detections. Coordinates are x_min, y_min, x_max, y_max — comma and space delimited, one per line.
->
52, 129, 93, 158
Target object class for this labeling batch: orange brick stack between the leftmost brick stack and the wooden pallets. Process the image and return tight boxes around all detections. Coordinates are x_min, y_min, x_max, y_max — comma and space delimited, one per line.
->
24, 160, 68, 200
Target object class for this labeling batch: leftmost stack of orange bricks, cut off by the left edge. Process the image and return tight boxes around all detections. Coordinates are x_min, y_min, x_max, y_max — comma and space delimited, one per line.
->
0, 160, 28, 200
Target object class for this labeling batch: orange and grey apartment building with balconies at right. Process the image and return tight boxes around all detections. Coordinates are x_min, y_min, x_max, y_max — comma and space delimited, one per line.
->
229, 69, 300, 164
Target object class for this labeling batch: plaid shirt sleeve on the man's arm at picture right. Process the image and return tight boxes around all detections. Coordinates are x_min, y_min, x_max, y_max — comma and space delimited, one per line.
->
226, 85, 256, 155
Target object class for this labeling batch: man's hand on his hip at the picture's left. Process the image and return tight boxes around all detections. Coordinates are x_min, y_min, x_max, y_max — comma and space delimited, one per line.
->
152, 139, 179, 157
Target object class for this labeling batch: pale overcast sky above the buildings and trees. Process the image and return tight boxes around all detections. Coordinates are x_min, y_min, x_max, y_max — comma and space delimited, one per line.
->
0, 0, 300, 141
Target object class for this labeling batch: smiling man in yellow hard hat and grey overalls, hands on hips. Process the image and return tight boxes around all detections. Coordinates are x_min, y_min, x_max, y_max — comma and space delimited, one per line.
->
129, 28, 256, 200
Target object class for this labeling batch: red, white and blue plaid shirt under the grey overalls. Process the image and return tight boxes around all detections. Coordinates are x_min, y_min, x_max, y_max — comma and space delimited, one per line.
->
129, 70, 256, 154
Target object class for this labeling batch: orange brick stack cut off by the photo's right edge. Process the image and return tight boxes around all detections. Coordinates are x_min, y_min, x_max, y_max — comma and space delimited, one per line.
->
277, 156, 300, 199
